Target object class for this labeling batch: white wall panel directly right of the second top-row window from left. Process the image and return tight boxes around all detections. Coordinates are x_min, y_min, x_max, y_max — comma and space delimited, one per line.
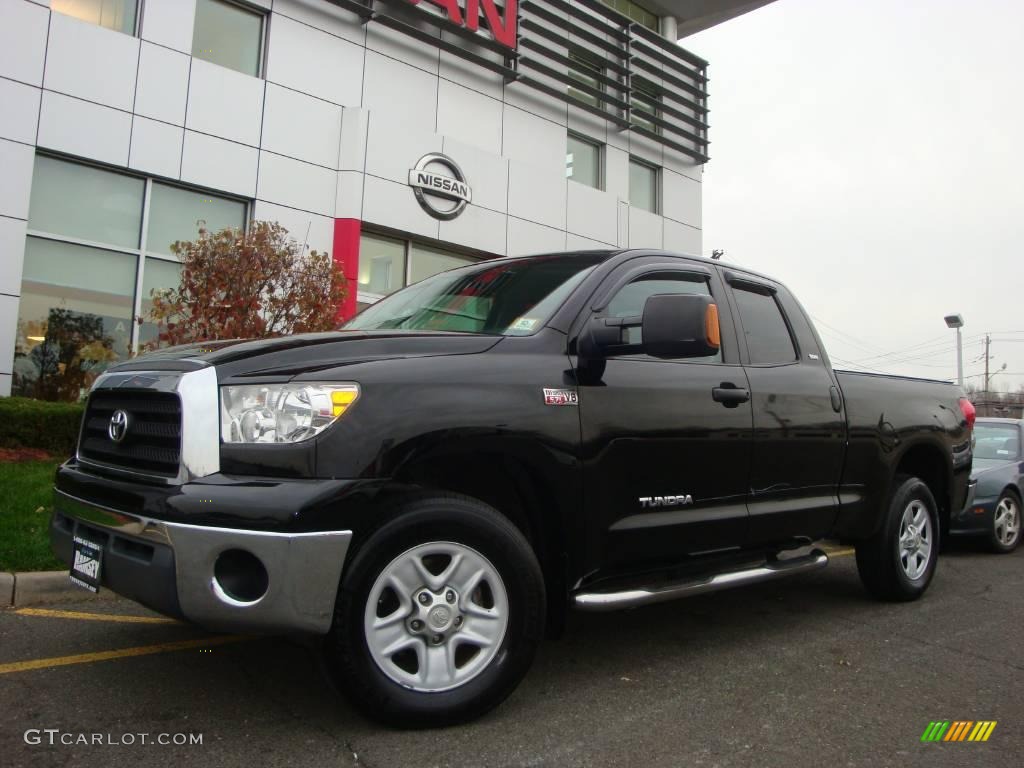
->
266, 15, 364, 106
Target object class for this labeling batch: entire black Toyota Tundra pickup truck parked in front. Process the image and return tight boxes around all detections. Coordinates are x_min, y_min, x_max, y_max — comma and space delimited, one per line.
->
51, 250, 974, 726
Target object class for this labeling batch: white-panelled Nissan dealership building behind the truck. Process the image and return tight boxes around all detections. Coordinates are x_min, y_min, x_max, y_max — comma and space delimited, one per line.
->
0, 0, 767, 398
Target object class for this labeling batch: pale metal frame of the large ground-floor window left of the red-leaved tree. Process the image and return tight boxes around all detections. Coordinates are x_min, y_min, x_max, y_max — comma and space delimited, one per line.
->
22, 152, 252, 355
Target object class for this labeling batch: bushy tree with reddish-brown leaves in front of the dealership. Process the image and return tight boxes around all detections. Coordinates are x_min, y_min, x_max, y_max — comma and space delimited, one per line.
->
139, 221, 346, 348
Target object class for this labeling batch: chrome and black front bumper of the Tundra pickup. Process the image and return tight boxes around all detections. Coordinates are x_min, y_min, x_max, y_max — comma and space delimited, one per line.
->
50, 490, 352, 634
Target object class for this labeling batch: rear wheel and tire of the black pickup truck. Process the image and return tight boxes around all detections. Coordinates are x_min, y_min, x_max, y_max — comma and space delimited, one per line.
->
856, 475, 940, 602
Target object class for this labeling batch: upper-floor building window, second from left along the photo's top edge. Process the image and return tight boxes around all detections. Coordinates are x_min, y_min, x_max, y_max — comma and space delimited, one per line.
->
193, 0, 263, 77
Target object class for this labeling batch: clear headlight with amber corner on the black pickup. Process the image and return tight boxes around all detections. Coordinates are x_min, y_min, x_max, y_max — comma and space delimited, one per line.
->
220, 383, 359, 442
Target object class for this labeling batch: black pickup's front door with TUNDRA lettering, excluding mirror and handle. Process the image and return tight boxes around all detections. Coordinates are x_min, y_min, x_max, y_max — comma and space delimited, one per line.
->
579, 257, 752, 571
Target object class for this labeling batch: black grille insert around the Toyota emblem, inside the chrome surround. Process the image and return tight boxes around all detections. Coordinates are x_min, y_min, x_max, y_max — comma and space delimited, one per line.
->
78, 389, 181, 477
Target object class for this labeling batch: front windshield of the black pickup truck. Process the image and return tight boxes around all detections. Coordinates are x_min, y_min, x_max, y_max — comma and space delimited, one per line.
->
342, 254, 603, 336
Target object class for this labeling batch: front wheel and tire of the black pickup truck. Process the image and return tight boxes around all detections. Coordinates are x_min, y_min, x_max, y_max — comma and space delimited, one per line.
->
325, 495, 546, 728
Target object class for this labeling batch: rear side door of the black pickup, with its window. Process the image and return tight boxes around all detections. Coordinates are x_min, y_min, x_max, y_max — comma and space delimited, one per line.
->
725, 270, 846, 546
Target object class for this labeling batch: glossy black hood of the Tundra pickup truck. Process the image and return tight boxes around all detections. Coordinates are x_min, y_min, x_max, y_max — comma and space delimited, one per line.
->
112, 331, 504, 376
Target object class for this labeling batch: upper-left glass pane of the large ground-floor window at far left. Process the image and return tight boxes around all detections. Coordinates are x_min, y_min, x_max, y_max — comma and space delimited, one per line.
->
29, 155, 145, 248
